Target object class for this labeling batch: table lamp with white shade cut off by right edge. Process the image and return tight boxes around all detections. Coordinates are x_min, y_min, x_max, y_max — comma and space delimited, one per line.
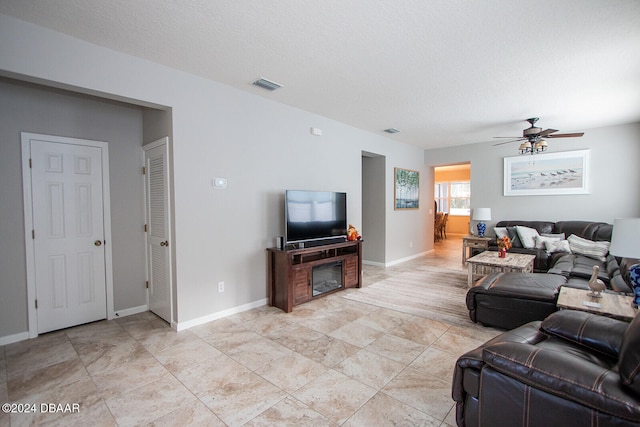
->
609, 218, 640, 305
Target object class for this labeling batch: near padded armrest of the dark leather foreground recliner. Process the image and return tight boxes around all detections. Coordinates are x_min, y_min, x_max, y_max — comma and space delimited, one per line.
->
482, 342, 640, 422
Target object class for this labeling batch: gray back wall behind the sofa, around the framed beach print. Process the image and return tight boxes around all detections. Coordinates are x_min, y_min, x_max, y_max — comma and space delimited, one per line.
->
425, 123, 640, 234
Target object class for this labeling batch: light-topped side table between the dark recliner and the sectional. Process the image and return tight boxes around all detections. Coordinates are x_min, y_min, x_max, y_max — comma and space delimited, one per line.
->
556, 286, 638, 322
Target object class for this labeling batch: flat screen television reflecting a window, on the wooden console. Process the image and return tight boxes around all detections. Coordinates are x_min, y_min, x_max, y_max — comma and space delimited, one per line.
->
285, 190, 347, 244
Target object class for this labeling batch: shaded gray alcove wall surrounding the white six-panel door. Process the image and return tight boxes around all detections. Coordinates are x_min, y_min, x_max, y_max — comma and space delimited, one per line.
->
0, 78, 146, 337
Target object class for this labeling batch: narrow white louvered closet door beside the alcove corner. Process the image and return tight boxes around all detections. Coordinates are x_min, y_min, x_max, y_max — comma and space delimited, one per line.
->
143, 138, 172, 323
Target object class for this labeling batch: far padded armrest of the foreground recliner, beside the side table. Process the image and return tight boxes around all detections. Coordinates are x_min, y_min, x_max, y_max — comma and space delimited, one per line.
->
541, 310, 629, 359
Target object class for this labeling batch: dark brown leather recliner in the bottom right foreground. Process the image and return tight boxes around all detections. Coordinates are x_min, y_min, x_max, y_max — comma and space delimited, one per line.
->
452, 310, 640, 427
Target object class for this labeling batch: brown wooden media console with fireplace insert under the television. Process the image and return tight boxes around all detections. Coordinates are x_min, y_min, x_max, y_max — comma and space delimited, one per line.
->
267, 240, 362, 313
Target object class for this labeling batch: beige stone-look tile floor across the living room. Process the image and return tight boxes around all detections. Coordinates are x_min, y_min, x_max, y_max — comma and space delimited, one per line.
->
0, 237, 498, 426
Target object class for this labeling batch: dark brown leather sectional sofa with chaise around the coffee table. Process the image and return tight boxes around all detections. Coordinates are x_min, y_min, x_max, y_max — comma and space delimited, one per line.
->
466, 221, 640, 329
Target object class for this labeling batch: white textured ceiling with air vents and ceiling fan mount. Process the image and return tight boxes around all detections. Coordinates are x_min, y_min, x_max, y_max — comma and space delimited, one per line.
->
0, 0, 640, 148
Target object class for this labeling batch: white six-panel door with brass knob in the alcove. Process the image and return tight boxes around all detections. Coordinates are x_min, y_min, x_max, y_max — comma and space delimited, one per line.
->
29, 137, 107, 333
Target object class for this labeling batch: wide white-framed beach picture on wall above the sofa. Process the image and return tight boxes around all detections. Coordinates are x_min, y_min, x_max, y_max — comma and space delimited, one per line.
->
504, 150, 590, 196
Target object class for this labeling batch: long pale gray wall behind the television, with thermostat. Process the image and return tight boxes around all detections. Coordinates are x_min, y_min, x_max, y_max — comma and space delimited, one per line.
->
0, 15, 433, 334
